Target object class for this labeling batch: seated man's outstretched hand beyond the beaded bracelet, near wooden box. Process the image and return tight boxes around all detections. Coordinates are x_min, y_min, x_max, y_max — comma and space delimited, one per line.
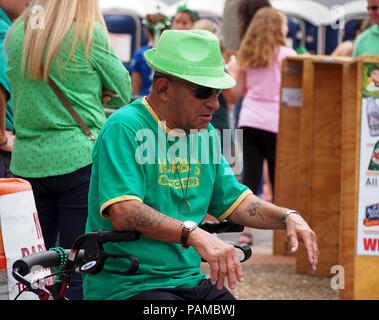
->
285, 214, 320, 273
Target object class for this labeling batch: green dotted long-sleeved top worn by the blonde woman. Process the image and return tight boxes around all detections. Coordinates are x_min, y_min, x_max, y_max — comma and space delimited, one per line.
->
8, 22, 131, 178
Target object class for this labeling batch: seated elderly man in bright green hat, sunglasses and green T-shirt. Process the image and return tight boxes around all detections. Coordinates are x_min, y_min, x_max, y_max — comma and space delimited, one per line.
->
84, 30, 319, 300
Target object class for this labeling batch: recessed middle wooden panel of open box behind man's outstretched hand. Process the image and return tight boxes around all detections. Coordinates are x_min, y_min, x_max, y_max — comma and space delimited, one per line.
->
297, 60, 342, 276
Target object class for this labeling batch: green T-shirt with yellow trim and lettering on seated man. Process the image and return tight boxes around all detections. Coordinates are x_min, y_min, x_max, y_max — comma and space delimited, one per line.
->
84, 99, 251, 299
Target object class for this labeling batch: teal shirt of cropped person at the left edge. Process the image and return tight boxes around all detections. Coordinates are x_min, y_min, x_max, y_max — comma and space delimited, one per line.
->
0, 8, 14, 131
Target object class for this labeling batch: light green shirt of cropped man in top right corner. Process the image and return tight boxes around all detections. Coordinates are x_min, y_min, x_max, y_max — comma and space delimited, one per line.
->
353, 24, 379, 57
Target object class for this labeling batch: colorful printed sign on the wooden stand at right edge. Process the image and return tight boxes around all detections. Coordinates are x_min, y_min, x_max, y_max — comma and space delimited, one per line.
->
357, 63, 379, 256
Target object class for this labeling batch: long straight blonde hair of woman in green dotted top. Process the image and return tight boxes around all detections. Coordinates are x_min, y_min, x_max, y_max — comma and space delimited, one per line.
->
11, 0, 107, 81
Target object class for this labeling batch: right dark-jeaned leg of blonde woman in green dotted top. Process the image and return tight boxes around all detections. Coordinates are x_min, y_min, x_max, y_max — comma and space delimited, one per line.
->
58, 166, 91, 300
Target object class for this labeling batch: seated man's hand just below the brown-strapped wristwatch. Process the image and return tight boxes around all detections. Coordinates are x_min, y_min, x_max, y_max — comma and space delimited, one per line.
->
188, 228, 243, 290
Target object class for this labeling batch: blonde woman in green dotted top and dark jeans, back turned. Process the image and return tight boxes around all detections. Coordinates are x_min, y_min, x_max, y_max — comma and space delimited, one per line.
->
7, 0, 131, 299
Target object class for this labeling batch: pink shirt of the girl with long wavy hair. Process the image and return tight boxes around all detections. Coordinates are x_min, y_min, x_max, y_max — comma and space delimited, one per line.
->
238, 47, 296, 133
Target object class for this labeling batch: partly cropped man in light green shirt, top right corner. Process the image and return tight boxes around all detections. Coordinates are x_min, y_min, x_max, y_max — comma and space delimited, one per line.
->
354, 0, 379, 57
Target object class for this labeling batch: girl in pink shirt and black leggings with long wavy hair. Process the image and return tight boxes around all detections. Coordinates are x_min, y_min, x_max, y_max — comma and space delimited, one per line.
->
229, 7, 296, 243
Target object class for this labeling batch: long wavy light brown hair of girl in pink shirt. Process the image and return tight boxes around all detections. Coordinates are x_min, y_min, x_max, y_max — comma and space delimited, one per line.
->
237, 7, 286, 68
